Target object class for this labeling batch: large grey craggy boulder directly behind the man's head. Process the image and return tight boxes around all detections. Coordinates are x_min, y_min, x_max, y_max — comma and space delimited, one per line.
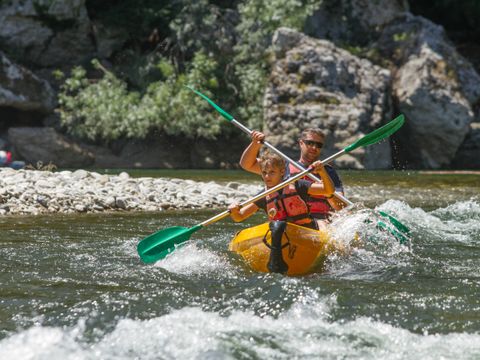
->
264, 28, 392, 169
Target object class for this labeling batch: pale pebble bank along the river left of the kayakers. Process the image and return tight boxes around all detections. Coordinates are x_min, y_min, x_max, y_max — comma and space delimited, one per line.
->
0, 168, 262, 215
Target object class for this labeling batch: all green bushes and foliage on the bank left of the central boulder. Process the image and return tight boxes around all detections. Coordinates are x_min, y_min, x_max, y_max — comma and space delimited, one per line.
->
56, 0, 320, 143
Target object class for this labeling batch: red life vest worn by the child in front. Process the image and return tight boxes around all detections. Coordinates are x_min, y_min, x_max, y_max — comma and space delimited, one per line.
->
265, 184, 315, 227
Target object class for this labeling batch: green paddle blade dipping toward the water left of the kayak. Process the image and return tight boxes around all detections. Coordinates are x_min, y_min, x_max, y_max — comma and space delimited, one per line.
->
137, 225, 202, 263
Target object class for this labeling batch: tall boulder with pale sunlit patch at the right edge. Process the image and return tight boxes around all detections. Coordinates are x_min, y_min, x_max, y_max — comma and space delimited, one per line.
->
376, 14, 480, 168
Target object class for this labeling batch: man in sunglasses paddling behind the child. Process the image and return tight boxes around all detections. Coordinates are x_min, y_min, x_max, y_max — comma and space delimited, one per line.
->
240, 128, 346, 214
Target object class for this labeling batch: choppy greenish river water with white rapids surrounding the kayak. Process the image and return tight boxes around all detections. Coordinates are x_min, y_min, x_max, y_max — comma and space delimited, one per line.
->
0, 171, 480, 360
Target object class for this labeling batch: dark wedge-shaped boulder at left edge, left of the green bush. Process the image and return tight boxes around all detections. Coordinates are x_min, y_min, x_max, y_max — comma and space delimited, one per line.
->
0, 51, 55, 112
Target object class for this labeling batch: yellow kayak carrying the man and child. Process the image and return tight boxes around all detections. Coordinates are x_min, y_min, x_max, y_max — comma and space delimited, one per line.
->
229, 222, 339, 275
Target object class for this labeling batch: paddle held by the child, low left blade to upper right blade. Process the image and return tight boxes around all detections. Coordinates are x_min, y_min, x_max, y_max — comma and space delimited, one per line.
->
137, 116, 404, 263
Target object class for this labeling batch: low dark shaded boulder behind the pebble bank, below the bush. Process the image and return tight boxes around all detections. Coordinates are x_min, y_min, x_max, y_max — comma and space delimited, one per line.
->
8, 127, 95, 168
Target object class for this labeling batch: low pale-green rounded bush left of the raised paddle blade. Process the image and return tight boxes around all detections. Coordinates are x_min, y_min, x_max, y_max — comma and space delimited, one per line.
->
59, 52, 220, 142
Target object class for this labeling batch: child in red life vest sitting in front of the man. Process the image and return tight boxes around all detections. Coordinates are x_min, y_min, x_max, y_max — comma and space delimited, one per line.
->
229, 151, 335, 229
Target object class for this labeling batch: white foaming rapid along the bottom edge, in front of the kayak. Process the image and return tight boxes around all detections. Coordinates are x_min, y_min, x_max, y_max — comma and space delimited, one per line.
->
0, 297, 480, 360
